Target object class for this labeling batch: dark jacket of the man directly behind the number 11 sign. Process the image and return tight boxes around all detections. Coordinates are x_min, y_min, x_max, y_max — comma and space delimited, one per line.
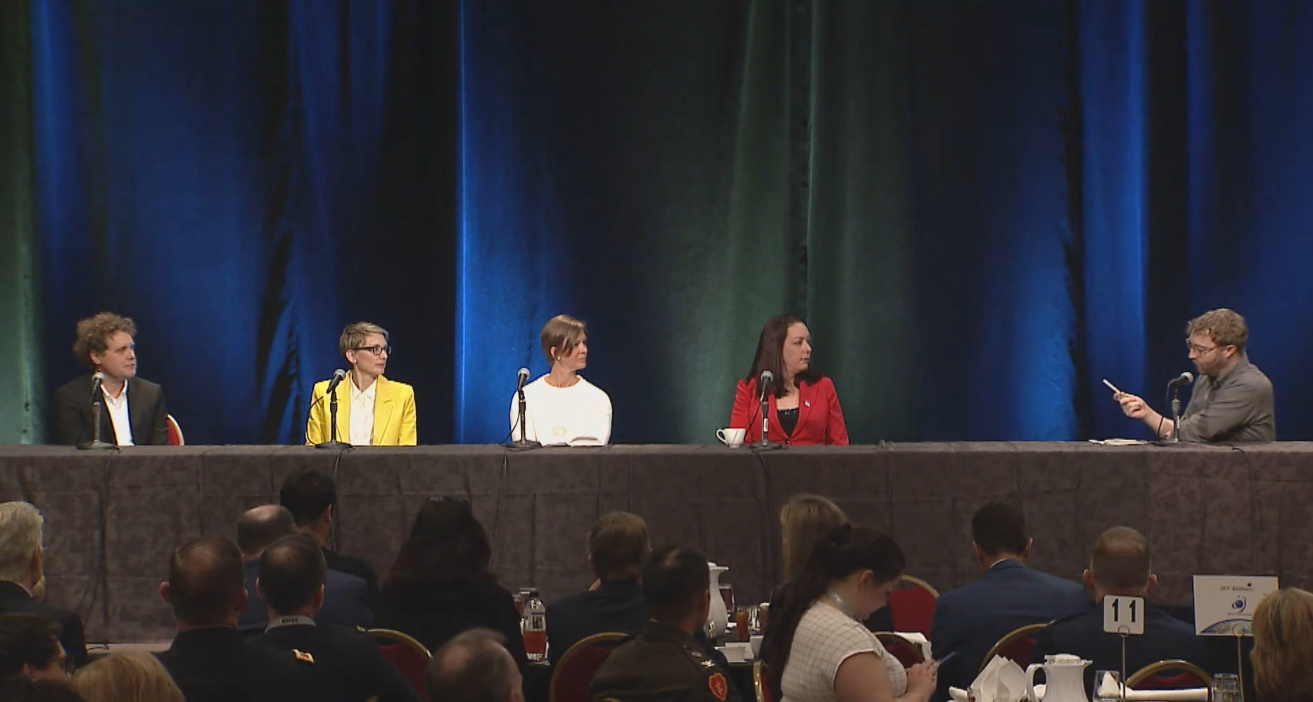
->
1035, 605, 1207, 689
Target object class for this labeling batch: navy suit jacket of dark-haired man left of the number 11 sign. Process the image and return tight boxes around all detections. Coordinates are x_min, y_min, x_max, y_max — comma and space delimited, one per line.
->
930, 559, 1090, 699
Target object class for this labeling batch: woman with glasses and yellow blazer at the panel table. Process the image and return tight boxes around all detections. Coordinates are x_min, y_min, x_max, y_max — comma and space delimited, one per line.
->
306, 321, 416, 446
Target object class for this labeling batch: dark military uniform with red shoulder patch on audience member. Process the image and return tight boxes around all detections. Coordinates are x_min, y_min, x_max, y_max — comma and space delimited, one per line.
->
588, 622, 739, 702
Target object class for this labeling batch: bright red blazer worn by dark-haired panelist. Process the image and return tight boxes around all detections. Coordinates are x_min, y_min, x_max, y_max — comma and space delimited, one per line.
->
730, 378, 848, 446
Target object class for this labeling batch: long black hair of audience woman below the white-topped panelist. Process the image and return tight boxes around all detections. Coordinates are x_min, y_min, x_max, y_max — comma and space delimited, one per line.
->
383, 497, 492, 593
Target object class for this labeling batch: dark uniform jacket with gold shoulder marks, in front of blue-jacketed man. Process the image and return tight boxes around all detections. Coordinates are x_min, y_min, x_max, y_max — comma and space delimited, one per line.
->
252, 625, 420, 702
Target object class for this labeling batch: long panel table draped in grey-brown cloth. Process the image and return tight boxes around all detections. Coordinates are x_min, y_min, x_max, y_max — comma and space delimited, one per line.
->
0, 444, 1313, 642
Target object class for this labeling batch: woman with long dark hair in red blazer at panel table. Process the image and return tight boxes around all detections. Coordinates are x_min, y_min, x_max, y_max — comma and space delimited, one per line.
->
730, 315, 848, 446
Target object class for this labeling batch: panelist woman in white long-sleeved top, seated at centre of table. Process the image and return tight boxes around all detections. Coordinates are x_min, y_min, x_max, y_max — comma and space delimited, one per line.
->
511, 315, 611, 446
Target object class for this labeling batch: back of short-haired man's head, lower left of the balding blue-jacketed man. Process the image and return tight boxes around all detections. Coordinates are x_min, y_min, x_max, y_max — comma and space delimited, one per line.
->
164, 537, 246, 626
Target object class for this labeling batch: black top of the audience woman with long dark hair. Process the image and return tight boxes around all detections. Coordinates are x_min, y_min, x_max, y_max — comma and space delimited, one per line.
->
374, 575, 529, 673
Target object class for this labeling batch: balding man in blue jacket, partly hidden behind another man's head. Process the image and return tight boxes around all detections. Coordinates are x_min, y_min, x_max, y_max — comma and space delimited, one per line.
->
238, 505, 374, 634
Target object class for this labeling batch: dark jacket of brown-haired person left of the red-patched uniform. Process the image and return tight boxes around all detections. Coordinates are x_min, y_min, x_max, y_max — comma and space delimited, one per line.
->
548, 580, 647, 664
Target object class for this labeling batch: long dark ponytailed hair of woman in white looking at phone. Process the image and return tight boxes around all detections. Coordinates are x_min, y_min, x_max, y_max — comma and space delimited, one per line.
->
762, 525, 907, 699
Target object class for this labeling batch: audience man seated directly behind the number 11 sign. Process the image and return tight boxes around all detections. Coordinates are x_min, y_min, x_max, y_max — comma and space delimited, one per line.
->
1035, 526, 1209, 689
